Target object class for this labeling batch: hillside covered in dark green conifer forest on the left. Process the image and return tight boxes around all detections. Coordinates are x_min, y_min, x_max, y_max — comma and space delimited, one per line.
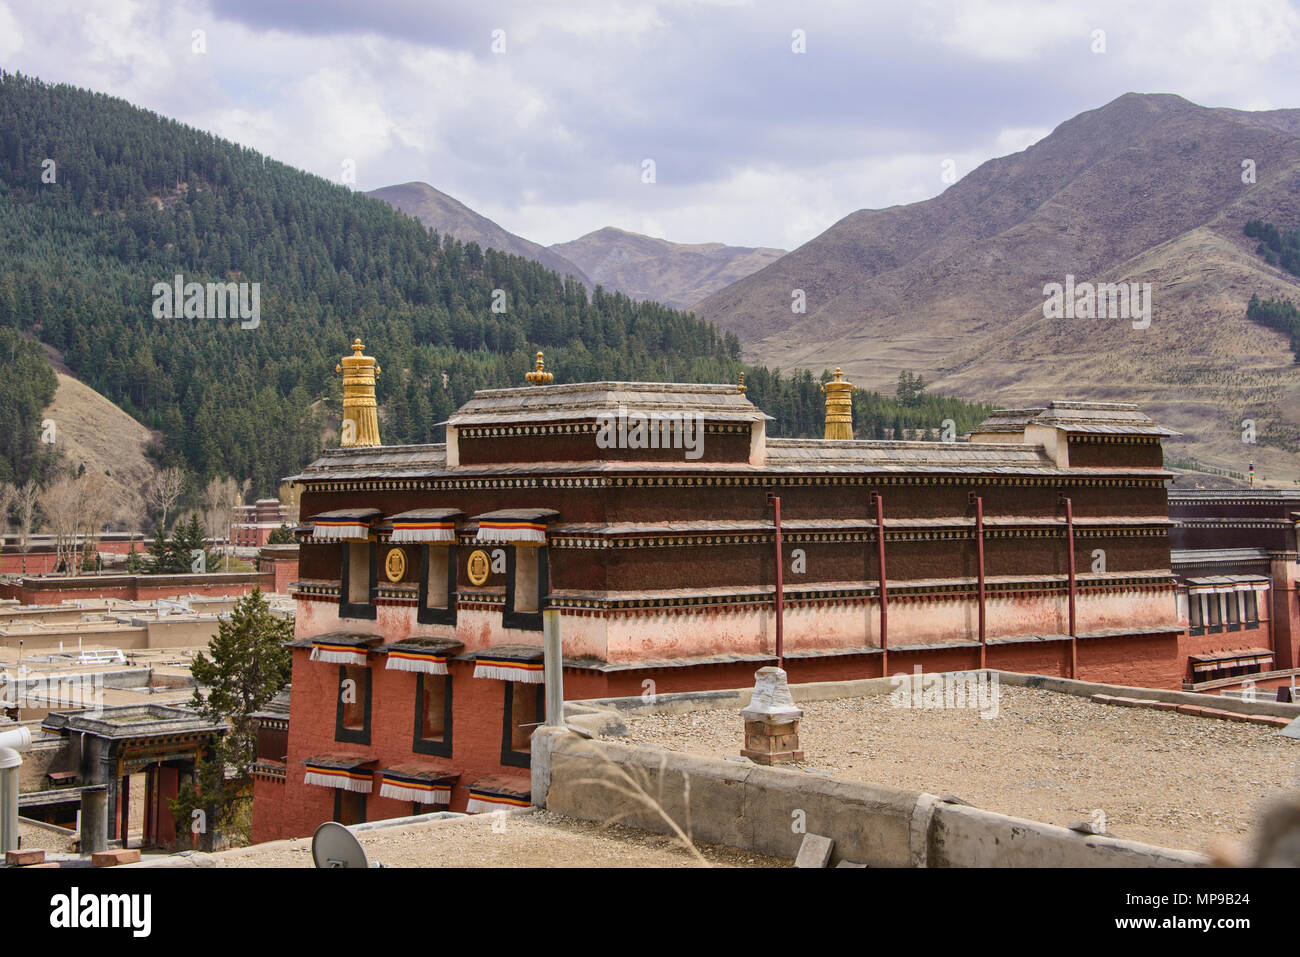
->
0, 73, 983, 494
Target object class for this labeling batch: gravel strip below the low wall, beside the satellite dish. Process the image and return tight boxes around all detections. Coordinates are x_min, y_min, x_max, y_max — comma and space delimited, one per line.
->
212, 810, 790, 867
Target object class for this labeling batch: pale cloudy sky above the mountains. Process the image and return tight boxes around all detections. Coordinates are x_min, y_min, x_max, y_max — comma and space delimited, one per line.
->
0, 0, 1300, 248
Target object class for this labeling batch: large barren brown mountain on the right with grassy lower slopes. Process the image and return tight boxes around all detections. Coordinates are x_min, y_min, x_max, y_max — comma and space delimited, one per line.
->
696, 94, 1300, 484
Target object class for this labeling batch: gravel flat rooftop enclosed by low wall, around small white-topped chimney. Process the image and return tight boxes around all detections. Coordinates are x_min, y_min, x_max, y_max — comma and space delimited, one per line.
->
627, 685, 1300, 850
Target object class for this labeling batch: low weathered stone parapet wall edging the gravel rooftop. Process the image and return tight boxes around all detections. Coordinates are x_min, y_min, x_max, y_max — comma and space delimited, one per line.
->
532, 672, 1216, 867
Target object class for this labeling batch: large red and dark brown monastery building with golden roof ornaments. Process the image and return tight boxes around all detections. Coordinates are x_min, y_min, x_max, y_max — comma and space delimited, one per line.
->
254, 342, 1187, 840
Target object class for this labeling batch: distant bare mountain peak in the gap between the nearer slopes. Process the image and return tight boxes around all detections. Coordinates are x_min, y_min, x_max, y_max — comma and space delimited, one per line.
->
550, 226, 785, 309
